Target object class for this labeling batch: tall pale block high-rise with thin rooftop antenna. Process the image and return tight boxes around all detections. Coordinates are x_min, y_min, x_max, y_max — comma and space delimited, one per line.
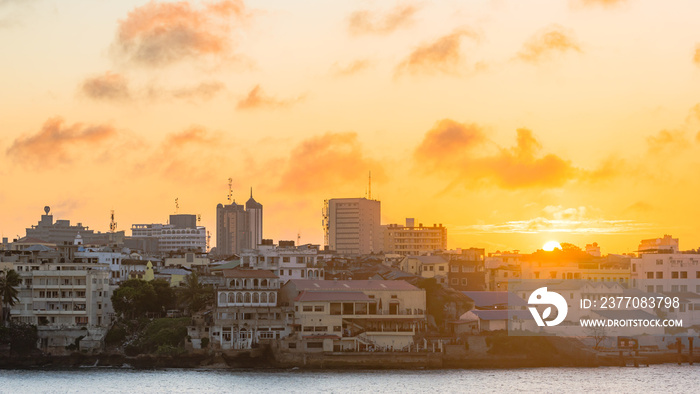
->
323, 198, 384, 254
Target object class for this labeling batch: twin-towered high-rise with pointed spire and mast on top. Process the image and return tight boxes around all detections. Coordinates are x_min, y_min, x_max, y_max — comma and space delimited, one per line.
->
216, 188, 263, 256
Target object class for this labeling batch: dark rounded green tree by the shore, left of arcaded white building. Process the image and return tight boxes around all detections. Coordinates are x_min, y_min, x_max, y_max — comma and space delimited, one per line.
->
112, 279, 175, 318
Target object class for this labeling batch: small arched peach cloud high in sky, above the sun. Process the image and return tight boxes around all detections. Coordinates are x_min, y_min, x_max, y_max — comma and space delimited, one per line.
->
516, 25, 583, 63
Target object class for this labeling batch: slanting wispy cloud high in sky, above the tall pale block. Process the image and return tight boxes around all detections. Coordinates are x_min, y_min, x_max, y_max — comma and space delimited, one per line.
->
396, 29, 478, 74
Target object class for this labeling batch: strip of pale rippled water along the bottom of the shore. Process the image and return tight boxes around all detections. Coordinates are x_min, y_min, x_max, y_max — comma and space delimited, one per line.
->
0, 365, 700, 394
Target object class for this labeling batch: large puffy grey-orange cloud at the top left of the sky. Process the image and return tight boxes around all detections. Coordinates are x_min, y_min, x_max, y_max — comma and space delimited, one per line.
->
114, 0, 246, 67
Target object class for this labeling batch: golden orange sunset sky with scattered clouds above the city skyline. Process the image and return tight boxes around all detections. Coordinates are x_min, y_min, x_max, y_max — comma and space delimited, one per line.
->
0, 0, 700, 254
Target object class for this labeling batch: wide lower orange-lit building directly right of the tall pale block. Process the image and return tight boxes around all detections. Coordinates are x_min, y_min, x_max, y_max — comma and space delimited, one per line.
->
382, 218, 447, 256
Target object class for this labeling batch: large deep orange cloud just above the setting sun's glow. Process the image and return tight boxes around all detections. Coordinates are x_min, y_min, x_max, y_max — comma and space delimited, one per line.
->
414, 119, 581, 189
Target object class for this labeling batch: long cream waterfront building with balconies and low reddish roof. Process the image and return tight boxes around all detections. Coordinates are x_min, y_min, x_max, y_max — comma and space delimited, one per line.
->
280, 279, 426, 351
